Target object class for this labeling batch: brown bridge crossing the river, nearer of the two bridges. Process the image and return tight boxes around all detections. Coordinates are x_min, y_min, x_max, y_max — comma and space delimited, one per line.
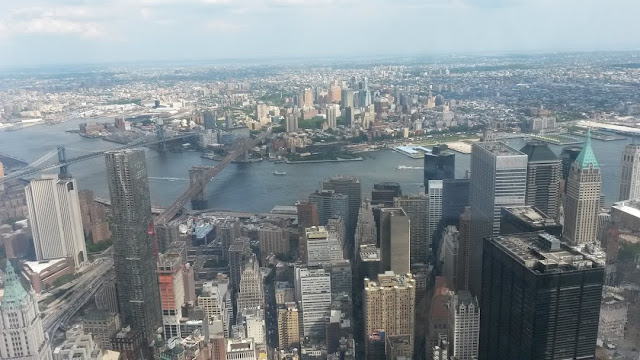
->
155, 128, 271, 224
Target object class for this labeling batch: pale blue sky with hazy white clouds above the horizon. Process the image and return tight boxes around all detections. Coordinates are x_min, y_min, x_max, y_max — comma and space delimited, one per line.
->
0, 0, 640, 66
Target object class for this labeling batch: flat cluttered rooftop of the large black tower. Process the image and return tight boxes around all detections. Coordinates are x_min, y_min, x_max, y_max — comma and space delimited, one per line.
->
488, 231, 604, 274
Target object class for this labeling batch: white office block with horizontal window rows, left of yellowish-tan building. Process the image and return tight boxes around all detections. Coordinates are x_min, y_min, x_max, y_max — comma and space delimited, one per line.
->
294, 266, 331, 340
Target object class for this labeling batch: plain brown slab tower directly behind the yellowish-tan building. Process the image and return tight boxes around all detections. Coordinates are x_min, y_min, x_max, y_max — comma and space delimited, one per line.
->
380, 208, 411, 274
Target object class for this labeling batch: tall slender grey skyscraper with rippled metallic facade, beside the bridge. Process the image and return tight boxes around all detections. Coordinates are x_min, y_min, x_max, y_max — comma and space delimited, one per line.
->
105, 149, 162, 345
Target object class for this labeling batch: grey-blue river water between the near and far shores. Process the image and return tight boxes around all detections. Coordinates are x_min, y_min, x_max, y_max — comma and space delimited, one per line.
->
0, 120, 630, 212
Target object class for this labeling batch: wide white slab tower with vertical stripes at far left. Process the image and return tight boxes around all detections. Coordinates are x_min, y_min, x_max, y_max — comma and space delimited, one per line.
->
25, 177, 87, 268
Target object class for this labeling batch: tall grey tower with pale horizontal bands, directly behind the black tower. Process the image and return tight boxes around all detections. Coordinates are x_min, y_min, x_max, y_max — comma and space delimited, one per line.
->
469, 142, 528, 298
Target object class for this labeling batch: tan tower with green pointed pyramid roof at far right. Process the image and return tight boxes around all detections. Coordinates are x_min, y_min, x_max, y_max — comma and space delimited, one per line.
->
563, 130, 602, 245
